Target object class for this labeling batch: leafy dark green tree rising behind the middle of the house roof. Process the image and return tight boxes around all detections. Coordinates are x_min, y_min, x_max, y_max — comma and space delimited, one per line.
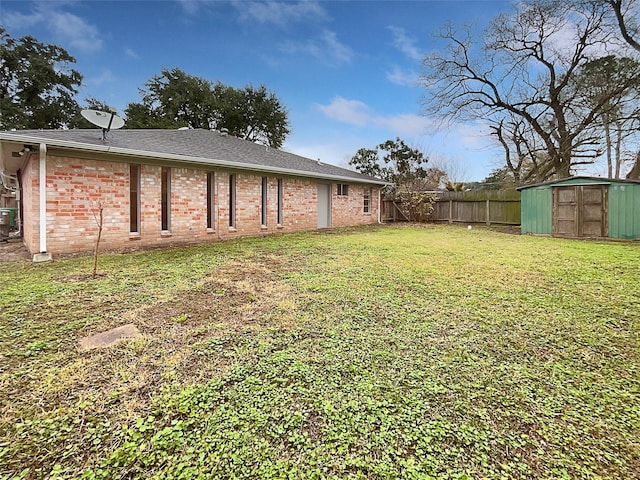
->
125, 68, 289, 148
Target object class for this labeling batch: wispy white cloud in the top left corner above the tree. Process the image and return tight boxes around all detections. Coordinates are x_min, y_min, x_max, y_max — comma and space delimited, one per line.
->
4, 2, 103, 55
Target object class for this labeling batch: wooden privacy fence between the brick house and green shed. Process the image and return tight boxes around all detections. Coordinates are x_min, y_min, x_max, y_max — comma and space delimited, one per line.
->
382, 190, 520, 225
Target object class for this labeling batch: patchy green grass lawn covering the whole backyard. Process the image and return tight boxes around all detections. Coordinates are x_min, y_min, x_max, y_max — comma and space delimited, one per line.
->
0, 226, 640, 479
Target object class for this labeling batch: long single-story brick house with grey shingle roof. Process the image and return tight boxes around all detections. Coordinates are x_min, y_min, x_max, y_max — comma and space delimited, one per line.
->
0, 129, 386, 256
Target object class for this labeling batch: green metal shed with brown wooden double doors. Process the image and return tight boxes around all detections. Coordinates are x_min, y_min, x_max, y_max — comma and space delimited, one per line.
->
518, 177, 640, 240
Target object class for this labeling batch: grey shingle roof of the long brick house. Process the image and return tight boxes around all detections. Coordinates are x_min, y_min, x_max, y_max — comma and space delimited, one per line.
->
0, 129, 388, 185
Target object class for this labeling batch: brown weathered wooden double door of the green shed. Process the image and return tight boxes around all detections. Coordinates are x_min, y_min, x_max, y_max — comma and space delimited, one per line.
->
553, 185, 607, 237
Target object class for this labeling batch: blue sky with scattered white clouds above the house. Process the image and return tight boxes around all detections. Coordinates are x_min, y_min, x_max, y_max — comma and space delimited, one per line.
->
0, 0, 510, 181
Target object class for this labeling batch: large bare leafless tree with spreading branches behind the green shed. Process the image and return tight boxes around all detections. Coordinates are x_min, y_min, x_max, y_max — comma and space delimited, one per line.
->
422, 0, 632, 180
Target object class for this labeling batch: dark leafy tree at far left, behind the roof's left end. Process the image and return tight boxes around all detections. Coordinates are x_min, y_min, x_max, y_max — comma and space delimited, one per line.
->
0, 26, 82, 130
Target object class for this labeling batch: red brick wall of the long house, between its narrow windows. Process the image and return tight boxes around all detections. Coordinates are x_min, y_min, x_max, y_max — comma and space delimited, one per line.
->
23, 154, 378, 254
